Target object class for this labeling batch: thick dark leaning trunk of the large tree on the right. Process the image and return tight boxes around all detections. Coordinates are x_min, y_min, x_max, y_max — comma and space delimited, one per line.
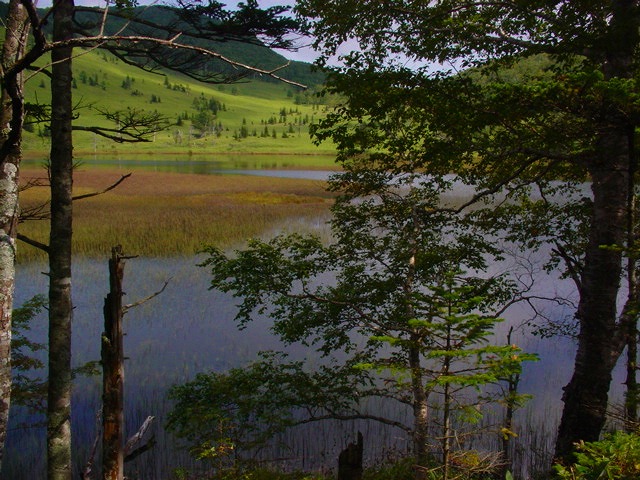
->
555, 0, 640, 459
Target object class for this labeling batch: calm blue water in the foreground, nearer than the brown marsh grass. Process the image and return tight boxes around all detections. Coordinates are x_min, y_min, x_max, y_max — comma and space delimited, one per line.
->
5, 257, 573, 480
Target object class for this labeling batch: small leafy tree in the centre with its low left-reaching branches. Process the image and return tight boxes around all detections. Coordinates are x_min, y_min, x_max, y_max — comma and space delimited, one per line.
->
170, 161, 532, 466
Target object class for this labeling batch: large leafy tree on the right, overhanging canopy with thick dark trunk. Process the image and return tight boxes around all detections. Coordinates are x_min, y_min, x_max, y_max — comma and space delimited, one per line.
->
296, 0, 640, 455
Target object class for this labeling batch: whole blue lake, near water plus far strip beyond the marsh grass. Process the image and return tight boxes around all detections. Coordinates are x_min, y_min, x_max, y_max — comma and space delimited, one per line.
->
3, 159, 622, 480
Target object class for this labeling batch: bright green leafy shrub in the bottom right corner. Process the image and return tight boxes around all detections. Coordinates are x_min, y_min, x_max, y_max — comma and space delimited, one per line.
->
554, 432, 640, 480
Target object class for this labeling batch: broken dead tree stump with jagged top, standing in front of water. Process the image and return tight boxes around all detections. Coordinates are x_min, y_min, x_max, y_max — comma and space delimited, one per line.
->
102, 247, 125, 480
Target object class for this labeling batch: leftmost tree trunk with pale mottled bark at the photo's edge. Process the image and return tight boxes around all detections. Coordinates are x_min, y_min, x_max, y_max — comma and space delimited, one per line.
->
0, 0, 28, 469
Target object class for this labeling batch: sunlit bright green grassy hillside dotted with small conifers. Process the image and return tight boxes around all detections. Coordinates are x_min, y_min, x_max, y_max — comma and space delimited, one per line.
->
24, 49, 333, 157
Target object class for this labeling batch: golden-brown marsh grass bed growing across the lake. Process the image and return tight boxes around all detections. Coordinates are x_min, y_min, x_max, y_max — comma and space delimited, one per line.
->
18, 168, 332, 262
